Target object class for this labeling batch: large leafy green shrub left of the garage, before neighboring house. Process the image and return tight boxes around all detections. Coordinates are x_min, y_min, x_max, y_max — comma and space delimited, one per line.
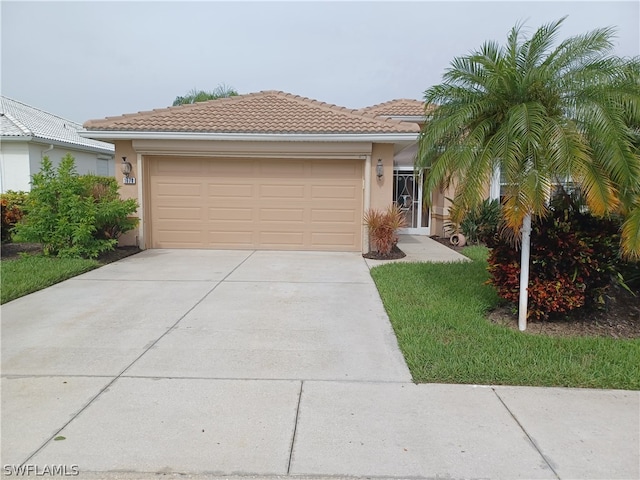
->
15, 154, 137, 258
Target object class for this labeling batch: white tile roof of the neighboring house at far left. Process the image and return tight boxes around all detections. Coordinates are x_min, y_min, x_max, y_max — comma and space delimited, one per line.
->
0, 96, 114, 154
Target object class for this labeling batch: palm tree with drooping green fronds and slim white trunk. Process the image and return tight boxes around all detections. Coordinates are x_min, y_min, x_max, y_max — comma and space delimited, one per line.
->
416, 18, 640, 330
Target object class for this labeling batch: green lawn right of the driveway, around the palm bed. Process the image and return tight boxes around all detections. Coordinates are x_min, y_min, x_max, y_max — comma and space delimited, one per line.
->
371, 247, 640, 390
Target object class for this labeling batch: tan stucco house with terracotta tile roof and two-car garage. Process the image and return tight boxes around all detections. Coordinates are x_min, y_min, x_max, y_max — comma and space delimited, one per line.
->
82, 91, 443, 251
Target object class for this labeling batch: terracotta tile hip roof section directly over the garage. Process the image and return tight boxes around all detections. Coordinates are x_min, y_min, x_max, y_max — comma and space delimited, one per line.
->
84, 90, 419, 134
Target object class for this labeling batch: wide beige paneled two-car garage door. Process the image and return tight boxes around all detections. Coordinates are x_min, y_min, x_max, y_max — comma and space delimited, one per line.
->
147, 157, 363, 251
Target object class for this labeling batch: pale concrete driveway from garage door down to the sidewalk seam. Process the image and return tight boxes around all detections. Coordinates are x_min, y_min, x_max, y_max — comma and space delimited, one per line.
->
2, 250, 411, 381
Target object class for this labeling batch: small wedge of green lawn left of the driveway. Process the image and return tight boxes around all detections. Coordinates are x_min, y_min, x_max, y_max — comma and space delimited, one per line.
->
0, 255, 100, 303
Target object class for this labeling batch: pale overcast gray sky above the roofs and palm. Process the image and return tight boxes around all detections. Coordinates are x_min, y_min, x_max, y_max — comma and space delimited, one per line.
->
0, 0, 640, 122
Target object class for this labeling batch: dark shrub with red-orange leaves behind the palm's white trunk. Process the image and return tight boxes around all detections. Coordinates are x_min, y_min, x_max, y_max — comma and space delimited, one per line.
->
488, 201, 622, 320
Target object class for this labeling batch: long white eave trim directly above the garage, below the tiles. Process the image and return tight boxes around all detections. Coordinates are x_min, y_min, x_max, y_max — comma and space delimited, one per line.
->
78, 130, 418, 143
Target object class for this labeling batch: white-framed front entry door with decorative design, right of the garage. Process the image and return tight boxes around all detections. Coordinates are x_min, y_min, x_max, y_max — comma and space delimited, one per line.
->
393, 167, 430, 235
